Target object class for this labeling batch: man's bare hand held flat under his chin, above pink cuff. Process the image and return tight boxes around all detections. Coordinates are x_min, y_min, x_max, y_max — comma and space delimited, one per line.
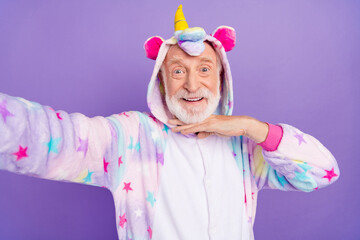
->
168, 115, 269, 143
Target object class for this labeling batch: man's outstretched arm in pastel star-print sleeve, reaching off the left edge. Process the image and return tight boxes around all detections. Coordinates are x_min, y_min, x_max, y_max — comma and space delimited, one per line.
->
0, 93, 133, 189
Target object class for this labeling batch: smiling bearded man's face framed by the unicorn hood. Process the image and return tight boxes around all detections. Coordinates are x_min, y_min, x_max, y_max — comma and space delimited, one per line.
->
159, 42, 220, 123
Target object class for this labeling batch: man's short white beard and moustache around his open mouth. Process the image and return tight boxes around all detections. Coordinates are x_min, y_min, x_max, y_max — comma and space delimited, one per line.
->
165, 86, 220, 124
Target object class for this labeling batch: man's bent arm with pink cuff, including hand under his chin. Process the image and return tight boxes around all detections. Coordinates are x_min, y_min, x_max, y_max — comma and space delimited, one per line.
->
169, 115, 340, 192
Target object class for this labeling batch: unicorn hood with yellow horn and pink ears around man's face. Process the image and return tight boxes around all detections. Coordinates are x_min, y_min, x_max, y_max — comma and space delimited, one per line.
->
144, 5, 236, 125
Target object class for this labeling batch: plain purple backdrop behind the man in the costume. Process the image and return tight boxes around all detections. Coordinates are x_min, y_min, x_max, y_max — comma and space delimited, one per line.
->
0, 0, 360, 240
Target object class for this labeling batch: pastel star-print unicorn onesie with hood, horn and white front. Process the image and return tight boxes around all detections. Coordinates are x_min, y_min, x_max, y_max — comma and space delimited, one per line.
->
0, 5, 340, 240
